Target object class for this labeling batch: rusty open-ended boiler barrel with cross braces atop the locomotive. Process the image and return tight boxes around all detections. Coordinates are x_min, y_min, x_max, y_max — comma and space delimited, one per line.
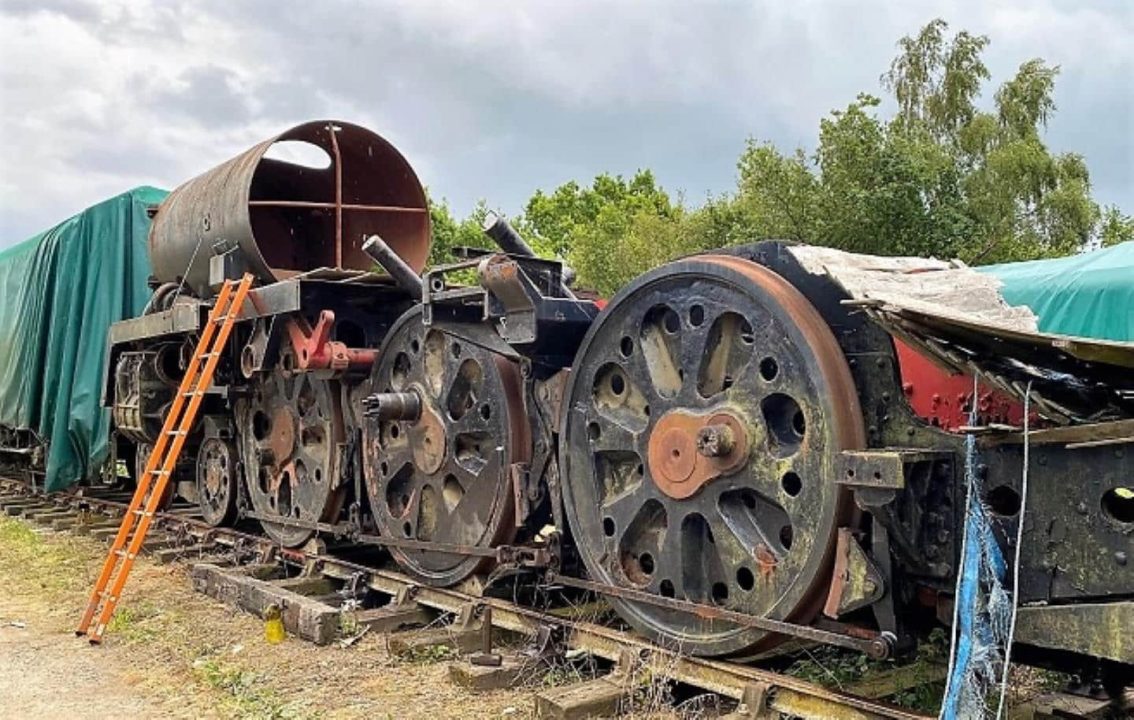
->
150, 120, 430, 297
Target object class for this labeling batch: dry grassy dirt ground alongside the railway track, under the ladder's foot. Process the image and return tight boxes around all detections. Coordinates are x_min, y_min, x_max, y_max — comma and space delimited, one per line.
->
0, 518, 533, 720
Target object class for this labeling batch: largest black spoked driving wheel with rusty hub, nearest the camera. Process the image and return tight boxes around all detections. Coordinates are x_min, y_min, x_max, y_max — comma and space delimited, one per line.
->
561, 255, 864, 654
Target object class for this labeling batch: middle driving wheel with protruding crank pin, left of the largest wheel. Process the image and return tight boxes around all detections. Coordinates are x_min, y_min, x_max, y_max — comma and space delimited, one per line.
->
363, 310, 530, 585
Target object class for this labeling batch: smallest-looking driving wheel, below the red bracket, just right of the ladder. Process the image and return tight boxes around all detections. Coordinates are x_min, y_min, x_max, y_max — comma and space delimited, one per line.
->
239, 370, 344, 547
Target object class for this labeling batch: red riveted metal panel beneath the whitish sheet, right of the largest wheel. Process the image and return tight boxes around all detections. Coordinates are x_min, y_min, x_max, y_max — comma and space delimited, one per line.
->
894, 339, 1024, 432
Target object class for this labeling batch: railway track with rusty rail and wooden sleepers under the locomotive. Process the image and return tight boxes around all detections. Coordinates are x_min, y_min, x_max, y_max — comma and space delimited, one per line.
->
0, 476, 930, 720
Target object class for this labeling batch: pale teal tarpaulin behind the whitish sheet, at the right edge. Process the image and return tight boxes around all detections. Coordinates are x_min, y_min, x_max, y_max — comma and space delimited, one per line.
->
976, 242, 1134, 342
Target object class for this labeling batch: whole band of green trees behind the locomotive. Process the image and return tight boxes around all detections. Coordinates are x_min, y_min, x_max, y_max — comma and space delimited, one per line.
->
432, 19, 1134, 296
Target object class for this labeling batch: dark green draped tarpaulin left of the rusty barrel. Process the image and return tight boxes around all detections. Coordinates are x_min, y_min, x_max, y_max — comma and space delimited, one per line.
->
0, 187, 166, 490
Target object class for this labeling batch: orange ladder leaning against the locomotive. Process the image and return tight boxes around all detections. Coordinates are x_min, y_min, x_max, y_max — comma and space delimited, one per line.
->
75, 273, 252, 645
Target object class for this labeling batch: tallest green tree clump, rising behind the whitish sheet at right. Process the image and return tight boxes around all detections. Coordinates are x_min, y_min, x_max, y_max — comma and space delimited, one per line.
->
736, 19, 1122, 263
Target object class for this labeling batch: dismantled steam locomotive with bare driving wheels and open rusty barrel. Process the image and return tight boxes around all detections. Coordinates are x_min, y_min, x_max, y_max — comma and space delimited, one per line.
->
2, 122, 1134, 702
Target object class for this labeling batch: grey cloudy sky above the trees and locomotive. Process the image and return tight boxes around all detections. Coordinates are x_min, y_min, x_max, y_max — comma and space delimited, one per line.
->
0, 0, 1134, 247
